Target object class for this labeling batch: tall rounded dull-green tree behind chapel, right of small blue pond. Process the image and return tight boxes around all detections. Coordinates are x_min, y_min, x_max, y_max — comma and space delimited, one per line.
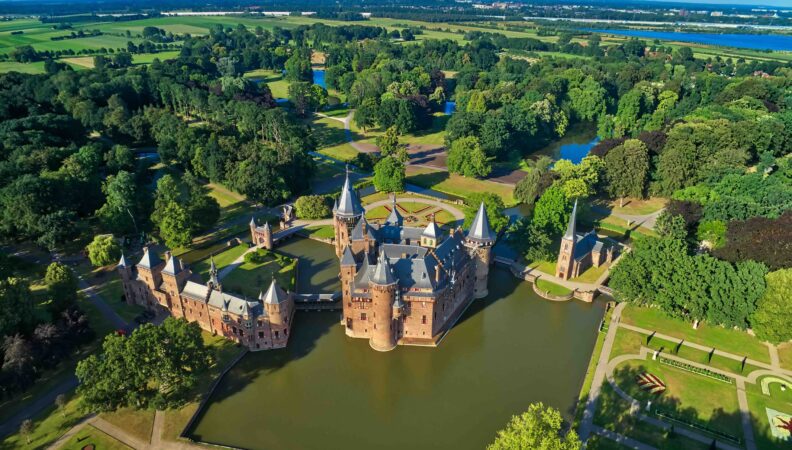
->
605, 139, 649, 206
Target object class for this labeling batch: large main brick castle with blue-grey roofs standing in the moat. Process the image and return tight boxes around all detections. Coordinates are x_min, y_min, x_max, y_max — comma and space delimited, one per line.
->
333, 176, 496, 351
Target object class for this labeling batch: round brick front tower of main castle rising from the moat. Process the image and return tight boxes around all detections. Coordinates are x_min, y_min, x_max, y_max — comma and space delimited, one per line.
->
369, 250, 399, 352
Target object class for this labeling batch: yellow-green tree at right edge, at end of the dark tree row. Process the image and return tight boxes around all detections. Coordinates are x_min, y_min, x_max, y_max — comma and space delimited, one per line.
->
751, 268, 792, 344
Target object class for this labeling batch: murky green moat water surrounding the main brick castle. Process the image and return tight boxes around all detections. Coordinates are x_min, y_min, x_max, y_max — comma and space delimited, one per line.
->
191, 237, 603, 450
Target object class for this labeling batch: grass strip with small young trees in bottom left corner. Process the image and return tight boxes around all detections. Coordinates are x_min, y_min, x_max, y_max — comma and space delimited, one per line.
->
0, 396, 85, 449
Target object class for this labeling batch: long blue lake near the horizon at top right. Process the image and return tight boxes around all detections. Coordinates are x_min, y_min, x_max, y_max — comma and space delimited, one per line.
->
587, 30, 792, 51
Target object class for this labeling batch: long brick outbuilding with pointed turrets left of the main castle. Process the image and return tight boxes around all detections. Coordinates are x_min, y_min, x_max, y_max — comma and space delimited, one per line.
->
118, 248, 295, 351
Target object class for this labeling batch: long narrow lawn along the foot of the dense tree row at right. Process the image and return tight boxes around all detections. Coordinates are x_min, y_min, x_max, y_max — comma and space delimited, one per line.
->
622, 305, 770, 364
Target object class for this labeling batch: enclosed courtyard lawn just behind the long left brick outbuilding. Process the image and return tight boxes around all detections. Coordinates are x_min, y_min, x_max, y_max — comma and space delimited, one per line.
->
221, 249, 297, 299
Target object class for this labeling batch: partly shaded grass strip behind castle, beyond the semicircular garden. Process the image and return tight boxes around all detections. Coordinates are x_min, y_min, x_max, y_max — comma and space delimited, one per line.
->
407, 166, 517, 206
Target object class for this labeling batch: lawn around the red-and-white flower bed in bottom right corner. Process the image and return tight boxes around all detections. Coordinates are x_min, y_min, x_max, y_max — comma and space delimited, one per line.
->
745, 379, 792, 450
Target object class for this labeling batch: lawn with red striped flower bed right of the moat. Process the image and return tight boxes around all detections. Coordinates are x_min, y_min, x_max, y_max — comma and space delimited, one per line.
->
614, 360, 742, 438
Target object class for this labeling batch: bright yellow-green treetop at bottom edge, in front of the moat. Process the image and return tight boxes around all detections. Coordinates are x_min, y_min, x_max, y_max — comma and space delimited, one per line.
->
487, 402, 581, 450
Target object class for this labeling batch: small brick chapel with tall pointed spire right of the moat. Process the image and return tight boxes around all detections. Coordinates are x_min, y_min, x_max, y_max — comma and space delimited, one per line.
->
556, 201, 617, 280
